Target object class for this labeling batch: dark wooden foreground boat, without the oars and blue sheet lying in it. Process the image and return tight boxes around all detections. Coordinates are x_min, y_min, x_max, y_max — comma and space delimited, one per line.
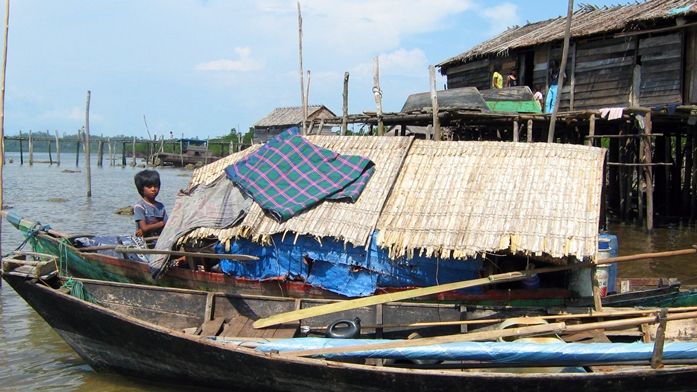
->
3, 260, 697, 392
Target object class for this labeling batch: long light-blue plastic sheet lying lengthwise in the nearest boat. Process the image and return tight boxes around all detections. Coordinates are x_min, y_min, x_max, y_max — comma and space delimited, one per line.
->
257, 338, 697, 366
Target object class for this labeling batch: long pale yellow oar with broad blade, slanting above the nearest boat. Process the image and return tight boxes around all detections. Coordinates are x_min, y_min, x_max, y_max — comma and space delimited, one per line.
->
253, 248, 697, 328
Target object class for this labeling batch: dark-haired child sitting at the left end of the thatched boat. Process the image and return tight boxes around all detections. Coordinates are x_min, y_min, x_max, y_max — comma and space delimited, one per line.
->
133, 170, 167, 237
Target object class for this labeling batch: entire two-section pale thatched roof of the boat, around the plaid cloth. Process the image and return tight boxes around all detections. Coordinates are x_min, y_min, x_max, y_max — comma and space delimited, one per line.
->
184, 136, 605, 258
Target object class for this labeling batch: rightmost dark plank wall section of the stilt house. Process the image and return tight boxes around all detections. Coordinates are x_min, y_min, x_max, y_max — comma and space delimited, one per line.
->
639, 32, 683, 107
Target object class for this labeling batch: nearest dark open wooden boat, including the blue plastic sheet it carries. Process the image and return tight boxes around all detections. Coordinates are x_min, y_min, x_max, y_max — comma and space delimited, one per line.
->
3, 256, 697, 392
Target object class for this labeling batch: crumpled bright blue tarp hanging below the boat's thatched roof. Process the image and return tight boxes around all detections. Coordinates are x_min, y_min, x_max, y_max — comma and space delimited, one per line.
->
215, 232, 482, 297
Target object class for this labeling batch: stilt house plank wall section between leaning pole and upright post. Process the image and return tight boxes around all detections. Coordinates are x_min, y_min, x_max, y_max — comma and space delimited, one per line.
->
560, 37, 636, 110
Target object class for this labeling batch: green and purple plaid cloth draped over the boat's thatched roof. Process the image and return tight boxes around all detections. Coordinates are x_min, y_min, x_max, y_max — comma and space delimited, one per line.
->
225, 127, 375, 222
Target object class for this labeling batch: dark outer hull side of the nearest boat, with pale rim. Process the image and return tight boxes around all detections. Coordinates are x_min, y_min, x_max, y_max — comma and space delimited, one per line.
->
4, 273, 697, 392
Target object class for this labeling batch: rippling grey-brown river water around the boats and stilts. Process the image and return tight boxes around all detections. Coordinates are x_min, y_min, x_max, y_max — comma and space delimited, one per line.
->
0, 153, 697, 391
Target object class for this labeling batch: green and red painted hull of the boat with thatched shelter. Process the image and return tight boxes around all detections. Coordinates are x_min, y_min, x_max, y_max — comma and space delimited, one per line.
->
6, 213, 697, 307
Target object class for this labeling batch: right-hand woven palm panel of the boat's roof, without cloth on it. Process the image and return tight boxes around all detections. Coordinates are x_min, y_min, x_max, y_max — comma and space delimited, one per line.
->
377, 140, 605, 258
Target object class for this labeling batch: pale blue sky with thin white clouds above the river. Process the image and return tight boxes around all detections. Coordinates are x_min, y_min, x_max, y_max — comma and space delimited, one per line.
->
0, 0, 618, 139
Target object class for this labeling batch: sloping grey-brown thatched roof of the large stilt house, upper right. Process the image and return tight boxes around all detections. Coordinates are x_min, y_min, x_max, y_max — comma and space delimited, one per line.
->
438, 0, 697, 67
